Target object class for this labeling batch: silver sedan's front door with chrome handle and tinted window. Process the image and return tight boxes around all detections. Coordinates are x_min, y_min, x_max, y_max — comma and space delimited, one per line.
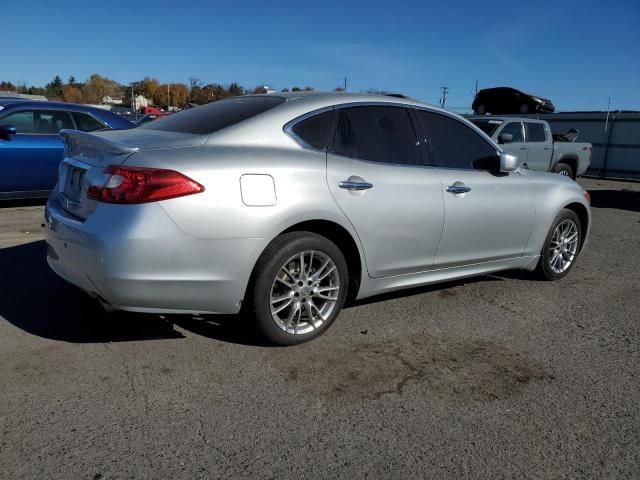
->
416, 109, 534, 267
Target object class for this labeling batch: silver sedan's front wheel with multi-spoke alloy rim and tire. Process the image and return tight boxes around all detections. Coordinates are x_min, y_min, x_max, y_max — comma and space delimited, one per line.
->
537, 208, 582, 280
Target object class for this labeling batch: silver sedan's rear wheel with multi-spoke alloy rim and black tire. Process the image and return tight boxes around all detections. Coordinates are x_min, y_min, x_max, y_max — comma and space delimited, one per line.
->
246, 232, 349, 345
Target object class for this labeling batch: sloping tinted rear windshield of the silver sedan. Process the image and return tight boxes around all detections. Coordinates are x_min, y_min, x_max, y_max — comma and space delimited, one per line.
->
138, 96, 284, 135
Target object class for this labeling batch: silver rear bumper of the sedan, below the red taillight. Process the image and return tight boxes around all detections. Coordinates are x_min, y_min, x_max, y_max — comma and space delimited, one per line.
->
45, 197, 262, 313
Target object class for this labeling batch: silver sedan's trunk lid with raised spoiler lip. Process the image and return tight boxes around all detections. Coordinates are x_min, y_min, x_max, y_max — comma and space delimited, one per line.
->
54, 129, 207, 220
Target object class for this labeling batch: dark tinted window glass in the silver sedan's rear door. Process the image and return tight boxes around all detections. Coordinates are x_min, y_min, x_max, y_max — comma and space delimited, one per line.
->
333, 107, 421, 165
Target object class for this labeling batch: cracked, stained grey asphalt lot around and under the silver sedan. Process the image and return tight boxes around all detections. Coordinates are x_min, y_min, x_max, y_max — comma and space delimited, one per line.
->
0, 179, 640, 480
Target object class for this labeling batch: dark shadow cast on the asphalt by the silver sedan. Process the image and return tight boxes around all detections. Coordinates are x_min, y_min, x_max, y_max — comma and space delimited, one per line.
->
0, 240, 516, 346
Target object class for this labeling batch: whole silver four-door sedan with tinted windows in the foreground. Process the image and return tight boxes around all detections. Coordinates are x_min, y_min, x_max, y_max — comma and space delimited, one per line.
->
45, 93, 591, 345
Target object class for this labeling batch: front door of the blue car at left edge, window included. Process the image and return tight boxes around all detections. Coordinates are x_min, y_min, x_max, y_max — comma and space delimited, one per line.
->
0, 108, 74, 192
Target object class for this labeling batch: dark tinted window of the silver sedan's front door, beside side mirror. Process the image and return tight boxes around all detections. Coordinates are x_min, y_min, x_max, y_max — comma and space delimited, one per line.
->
416, 110, 497, 170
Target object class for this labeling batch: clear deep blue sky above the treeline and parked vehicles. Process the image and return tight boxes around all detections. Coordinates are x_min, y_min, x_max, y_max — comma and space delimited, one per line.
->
0, 0, 640, 110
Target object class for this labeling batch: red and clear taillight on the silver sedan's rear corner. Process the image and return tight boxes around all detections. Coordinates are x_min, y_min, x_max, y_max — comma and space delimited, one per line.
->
87, 165, 204, 203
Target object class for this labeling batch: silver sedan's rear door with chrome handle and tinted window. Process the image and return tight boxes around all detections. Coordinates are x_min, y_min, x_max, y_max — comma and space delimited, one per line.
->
327, 104, 444, 278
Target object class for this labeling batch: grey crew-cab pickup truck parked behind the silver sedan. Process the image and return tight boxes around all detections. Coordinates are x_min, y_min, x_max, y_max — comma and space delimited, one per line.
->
467, 115, 593, 180
